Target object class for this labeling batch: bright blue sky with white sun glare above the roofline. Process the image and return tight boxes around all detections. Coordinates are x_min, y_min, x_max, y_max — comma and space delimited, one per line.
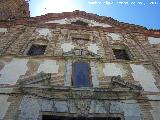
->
29, 0, 160, 29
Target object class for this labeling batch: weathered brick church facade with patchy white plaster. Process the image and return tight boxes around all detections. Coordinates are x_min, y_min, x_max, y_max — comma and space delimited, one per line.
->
0, 0, 160, 120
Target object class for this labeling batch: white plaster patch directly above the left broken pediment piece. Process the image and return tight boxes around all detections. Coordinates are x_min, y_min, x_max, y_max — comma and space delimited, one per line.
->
37, 60, 59, 73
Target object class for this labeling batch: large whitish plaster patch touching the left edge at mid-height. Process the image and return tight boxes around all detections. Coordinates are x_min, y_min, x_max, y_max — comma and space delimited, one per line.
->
0, 58, 28, 84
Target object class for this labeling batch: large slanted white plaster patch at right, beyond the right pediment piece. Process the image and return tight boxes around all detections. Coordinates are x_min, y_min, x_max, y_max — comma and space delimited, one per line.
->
130, 64, 159, 92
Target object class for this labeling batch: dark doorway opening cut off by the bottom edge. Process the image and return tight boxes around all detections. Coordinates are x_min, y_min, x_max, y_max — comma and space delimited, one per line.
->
42, 115, 121, 120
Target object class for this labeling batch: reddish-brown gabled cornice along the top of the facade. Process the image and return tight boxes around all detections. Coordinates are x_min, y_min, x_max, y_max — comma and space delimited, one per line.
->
0, 10, 160, 37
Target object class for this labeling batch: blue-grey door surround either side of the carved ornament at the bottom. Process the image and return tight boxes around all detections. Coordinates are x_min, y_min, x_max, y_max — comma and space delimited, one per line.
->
18, 96, 141, 120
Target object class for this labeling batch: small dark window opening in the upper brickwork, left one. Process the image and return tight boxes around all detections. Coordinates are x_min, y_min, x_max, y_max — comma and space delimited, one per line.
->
27, 45, 47, 56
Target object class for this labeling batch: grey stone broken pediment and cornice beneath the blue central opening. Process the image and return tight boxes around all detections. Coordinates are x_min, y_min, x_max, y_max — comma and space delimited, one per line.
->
18, 72, 143, 99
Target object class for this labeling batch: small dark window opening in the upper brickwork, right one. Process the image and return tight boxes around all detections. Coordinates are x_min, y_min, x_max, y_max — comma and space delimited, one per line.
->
112, 49, 130, 60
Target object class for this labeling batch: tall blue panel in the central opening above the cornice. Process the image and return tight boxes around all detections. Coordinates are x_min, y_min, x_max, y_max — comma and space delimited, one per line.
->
73, 62, 90, 87
